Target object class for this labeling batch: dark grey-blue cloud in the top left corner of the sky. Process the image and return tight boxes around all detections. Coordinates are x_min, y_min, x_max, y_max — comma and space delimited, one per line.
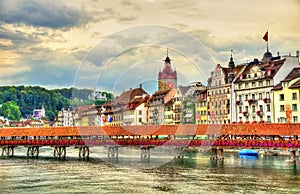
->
0, 0, 91, 28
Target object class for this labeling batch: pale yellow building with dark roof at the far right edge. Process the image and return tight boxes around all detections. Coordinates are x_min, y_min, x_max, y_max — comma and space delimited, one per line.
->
272, 67, 300, 123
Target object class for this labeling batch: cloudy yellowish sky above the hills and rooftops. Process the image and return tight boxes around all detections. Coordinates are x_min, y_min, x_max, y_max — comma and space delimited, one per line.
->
0, 0, 300, 93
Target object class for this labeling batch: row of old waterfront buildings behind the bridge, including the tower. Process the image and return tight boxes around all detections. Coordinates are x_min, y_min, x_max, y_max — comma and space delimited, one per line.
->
75, 51, 300, 126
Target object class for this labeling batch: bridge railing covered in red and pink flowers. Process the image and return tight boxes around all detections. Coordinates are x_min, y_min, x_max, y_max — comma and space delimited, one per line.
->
0, 139, 300, 148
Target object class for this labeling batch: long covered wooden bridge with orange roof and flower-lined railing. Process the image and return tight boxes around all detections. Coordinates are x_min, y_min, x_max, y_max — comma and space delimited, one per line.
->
0, 123, 300, 161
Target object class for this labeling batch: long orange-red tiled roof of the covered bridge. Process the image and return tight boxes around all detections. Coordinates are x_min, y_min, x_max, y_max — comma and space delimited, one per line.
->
0, 123, 300, 137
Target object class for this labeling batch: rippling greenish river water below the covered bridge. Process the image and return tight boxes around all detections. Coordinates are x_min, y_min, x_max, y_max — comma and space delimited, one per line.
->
0, 148, 300, 193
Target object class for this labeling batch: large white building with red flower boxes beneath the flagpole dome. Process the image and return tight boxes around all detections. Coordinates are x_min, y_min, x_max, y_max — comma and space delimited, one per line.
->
234, 52, 299, 123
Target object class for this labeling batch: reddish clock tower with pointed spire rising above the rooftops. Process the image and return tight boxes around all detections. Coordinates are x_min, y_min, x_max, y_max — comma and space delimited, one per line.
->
158, 50, 177, 91
